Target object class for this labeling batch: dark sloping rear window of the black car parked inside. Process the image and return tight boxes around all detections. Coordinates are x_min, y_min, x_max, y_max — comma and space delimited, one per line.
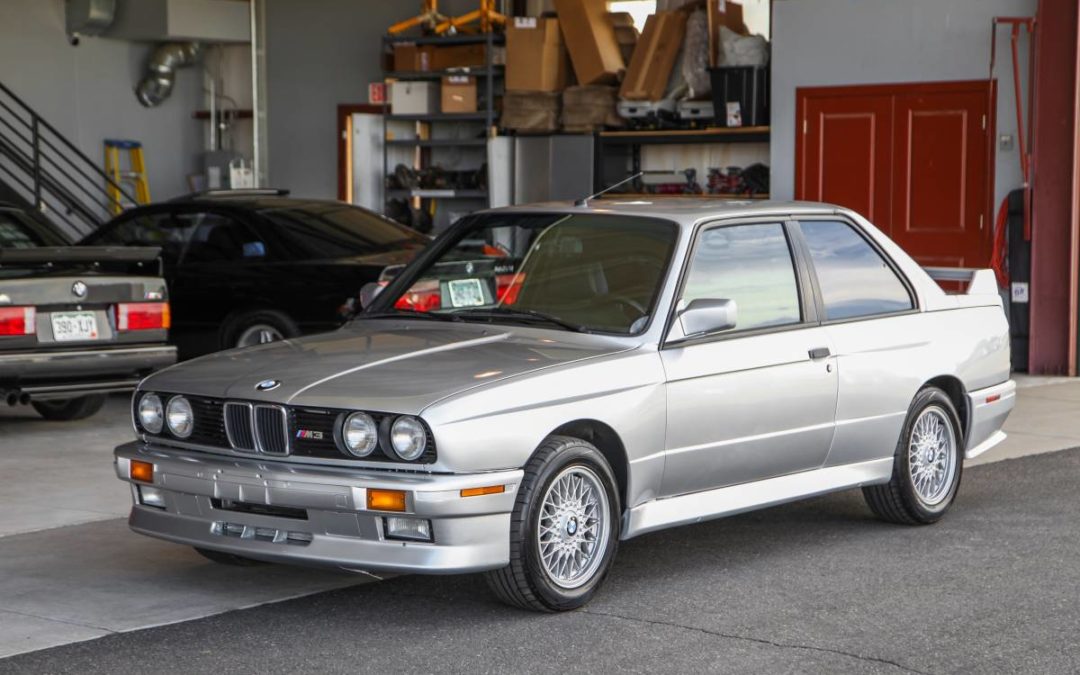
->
259, 203, 428, 259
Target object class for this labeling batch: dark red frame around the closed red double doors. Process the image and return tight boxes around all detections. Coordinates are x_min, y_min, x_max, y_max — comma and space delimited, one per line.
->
794, 79, 998, 254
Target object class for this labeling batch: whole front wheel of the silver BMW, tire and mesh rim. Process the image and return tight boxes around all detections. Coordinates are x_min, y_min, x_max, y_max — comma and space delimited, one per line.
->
487, 436, 621, 611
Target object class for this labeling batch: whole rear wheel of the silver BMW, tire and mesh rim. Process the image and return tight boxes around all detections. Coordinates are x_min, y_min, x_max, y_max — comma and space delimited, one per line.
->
863, 387, 963, 525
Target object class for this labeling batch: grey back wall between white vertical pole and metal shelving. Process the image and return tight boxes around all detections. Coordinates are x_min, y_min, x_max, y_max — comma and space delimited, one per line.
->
266, 0, 476, 199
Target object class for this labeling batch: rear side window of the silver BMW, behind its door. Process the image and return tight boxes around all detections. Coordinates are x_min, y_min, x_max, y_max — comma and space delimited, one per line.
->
799, 220, 914, 321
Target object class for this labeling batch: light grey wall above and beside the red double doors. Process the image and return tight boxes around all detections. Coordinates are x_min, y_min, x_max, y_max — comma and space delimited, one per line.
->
771, 0, 1036, 210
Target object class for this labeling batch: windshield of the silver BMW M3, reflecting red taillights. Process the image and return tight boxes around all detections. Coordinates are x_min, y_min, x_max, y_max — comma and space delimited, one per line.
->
372, 213, 677, 335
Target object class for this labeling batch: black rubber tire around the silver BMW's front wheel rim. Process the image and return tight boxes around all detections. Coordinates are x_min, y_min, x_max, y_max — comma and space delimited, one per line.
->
486, 436, 622, 612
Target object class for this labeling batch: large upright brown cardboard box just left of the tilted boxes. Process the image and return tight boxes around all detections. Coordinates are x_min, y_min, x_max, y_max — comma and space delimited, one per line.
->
507, 16, 567, 92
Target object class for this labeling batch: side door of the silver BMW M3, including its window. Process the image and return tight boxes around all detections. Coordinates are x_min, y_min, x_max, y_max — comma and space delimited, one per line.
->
660, 220, 837, 496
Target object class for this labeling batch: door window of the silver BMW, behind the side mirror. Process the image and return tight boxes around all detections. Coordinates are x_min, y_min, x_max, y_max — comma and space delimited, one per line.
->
680, 222, 802, 330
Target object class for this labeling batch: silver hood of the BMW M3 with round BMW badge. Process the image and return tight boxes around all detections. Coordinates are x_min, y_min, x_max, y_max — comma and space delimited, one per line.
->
140, 320, 632, 414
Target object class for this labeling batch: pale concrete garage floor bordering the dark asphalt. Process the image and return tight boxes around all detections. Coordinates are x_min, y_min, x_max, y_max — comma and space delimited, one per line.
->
0, 378, 1080, 658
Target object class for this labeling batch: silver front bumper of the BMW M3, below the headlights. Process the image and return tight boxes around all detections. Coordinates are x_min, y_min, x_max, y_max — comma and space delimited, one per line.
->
114, 442, 523, 573
